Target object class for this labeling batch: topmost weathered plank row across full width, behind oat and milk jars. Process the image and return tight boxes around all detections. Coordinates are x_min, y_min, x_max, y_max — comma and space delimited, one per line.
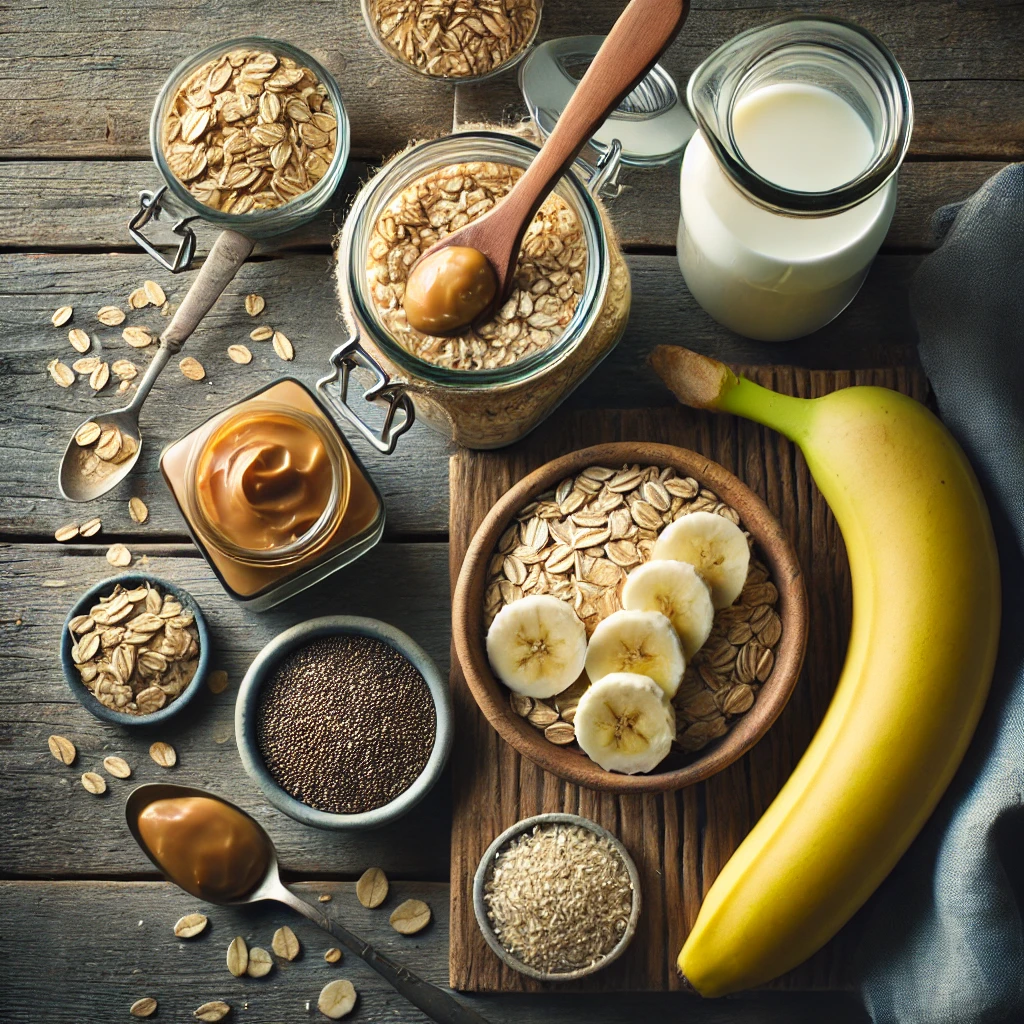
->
0, 0, 1024, 159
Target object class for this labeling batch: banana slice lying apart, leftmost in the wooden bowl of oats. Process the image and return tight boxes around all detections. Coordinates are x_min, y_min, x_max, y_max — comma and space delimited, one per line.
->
487, 594, 587, 697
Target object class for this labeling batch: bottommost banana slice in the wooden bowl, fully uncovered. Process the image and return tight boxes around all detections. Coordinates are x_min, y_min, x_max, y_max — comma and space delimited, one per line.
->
573, 672, 676, 775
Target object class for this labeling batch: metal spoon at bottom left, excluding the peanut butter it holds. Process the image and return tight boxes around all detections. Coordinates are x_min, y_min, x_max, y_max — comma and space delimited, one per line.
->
125, 782, 487, 1024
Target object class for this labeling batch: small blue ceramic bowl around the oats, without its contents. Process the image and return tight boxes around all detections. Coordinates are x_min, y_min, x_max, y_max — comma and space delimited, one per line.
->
60, 572, 210, 728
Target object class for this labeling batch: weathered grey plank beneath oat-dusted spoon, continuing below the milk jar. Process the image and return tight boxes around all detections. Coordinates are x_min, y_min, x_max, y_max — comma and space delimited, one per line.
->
0, 254, 919, 541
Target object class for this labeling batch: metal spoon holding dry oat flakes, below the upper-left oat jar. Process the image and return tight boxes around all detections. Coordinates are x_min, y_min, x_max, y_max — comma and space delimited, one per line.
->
58, 230, 255, 502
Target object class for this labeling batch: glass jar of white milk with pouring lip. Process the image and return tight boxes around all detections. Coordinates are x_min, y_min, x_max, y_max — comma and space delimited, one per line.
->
678, 16, 913, 341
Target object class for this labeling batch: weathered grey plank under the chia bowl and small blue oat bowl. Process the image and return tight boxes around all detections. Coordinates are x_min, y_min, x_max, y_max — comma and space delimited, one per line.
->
0, 544, 450, 880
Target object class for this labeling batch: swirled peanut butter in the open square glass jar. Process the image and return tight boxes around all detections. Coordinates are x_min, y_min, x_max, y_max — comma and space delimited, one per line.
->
196, 409, 334, 551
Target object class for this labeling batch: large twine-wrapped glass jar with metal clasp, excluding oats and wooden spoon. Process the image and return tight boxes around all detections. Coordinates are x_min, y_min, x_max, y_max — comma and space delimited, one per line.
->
317, 131, 631, 451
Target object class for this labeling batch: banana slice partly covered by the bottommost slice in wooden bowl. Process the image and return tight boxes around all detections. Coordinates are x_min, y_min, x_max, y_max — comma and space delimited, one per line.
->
587, 610, 686, 697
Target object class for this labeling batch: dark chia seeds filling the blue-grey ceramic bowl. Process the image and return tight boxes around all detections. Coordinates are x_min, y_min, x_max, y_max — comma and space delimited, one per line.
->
256, 636, 437, 814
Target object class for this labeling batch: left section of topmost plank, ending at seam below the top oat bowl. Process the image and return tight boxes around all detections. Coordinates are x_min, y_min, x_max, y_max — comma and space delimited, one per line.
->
0, 0, 453, 159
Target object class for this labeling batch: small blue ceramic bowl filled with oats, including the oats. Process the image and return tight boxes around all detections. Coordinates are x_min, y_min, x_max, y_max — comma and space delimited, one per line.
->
60, 572, 210, 728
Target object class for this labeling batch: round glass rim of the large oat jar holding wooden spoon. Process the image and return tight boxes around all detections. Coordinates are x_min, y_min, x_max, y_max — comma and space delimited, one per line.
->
338, 129, 610, 390
